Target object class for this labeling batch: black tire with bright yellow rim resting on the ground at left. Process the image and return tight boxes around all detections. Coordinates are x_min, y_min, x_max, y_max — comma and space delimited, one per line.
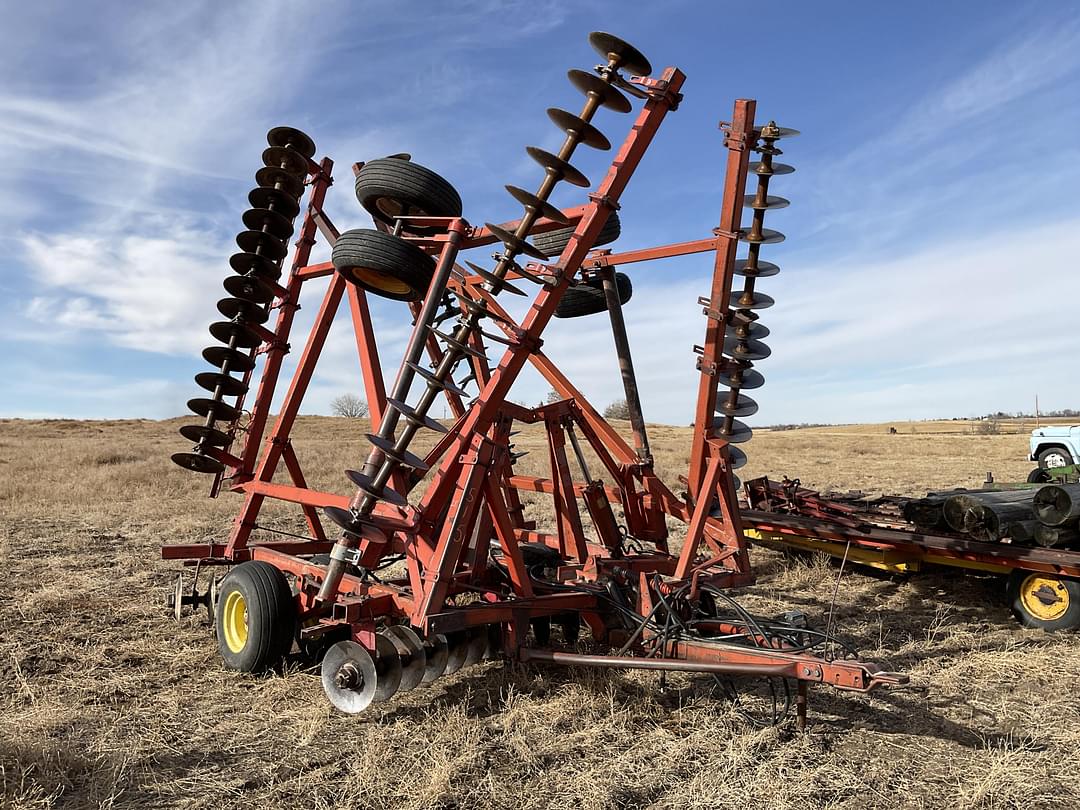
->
214, 561, 296, 672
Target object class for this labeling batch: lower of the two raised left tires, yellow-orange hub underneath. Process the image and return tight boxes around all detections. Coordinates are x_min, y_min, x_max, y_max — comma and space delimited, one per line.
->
330, 228, 435, 301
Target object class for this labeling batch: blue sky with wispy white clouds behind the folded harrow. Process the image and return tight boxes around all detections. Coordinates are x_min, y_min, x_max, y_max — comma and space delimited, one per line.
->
0, 0, 1080, 424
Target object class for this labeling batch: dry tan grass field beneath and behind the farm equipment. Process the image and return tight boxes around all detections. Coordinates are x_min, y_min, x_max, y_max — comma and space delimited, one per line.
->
0, 417, 1080, 810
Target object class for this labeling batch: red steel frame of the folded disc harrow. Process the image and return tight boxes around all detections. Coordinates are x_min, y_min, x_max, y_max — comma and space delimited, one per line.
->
162, 76, 896, 689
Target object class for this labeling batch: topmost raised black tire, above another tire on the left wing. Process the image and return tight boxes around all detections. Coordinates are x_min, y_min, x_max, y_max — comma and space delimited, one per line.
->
356, 158, 461, 233
